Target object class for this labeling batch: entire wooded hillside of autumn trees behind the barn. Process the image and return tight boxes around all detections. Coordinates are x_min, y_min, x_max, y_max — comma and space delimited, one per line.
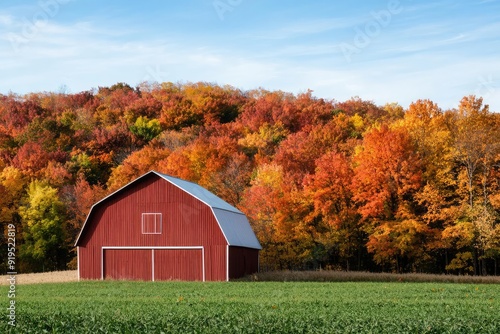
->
0, 83, 500, 275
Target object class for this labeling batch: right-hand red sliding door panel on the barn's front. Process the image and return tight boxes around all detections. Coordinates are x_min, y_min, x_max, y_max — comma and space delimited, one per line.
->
153, 249, 203, 281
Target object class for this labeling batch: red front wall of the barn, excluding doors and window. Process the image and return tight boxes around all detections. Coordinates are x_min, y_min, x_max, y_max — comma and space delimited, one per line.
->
79, 174, 226, 280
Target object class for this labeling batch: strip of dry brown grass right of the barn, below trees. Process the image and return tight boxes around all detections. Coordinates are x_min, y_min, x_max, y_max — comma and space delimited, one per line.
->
245, 270, 500, 284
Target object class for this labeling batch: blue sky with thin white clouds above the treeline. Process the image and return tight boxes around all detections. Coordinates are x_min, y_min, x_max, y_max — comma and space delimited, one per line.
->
0, 0, 500, 112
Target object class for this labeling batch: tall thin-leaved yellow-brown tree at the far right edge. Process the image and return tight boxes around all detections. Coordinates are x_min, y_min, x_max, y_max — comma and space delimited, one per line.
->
454, 96, 500, 274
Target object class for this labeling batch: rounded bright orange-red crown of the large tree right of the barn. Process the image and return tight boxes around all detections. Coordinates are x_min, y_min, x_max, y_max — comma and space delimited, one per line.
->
352, 125, 422, 220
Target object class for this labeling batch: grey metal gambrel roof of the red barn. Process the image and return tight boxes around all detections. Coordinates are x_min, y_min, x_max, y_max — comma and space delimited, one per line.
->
75, 171, 262, 249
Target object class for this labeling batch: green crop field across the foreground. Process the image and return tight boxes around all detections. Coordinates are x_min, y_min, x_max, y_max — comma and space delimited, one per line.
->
0, 282, 500, 333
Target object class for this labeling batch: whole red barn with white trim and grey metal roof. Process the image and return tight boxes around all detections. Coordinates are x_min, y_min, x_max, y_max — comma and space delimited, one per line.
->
75, 171, 261, 281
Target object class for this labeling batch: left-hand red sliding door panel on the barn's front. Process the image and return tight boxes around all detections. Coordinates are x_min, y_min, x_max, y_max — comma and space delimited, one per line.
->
103, 249, 152, 281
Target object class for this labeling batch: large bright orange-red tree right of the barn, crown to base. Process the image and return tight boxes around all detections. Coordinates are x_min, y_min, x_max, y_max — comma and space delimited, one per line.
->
352, 125, 425, 270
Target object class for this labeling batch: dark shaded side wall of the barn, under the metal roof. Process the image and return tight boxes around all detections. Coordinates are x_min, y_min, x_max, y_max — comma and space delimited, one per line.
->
229, 246, 259, 279
